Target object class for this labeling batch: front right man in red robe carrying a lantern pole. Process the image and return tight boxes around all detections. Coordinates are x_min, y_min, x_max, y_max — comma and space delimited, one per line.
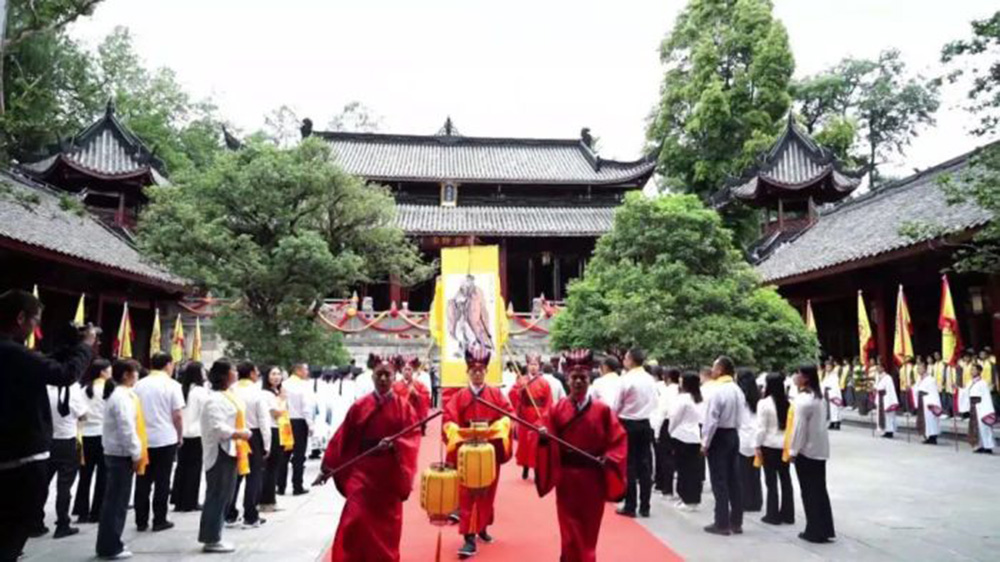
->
535, 350, 628, 562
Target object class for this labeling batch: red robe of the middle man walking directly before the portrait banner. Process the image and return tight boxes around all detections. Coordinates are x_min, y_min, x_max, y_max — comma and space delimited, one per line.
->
442, 386, 511, 535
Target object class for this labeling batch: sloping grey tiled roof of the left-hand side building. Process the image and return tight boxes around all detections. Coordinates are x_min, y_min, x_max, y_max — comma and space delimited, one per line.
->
0, 171, 186, 290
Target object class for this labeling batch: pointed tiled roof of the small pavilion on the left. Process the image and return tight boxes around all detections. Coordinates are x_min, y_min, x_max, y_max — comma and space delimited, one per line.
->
24, 101, 165, 184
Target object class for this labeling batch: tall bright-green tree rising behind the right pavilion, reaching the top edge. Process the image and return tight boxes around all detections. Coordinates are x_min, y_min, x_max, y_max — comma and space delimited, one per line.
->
647, 0, 795, 203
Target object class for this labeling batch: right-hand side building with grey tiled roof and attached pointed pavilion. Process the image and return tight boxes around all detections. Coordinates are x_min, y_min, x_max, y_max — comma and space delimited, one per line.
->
716, 118, 1000, 367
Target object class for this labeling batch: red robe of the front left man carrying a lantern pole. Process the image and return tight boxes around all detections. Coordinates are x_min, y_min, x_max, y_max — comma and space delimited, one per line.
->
323, 392, 420, 562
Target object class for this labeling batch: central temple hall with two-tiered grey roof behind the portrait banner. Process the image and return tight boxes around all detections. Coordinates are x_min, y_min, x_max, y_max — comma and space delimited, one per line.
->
302, 119, 655, 310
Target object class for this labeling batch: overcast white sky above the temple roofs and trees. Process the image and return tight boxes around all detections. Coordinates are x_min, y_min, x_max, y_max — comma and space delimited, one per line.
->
68, 0, 997, 174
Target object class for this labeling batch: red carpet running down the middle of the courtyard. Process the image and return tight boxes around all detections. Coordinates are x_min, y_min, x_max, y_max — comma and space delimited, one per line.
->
325, 423, 683, 562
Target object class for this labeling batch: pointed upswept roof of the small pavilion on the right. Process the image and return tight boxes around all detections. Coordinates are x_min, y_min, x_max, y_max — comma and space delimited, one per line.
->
716, 114, 861, 206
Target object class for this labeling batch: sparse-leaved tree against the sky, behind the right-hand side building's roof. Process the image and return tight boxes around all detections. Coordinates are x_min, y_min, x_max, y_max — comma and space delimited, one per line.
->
792, 49, 940, 185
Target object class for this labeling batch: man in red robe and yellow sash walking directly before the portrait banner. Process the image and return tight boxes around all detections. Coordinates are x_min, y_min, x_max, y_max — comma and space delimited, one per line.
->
443, 347, 511, 559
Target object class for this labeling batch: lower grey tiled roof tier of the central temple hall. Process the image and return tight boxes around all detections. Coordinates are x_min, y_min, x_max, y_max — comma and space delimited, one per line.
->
396, 205, 615, 237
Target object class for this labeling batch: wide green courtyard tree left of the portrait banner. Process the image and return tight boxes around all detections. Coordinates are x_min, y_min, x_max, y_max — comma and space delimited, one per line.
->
139, 139, 432, 365
